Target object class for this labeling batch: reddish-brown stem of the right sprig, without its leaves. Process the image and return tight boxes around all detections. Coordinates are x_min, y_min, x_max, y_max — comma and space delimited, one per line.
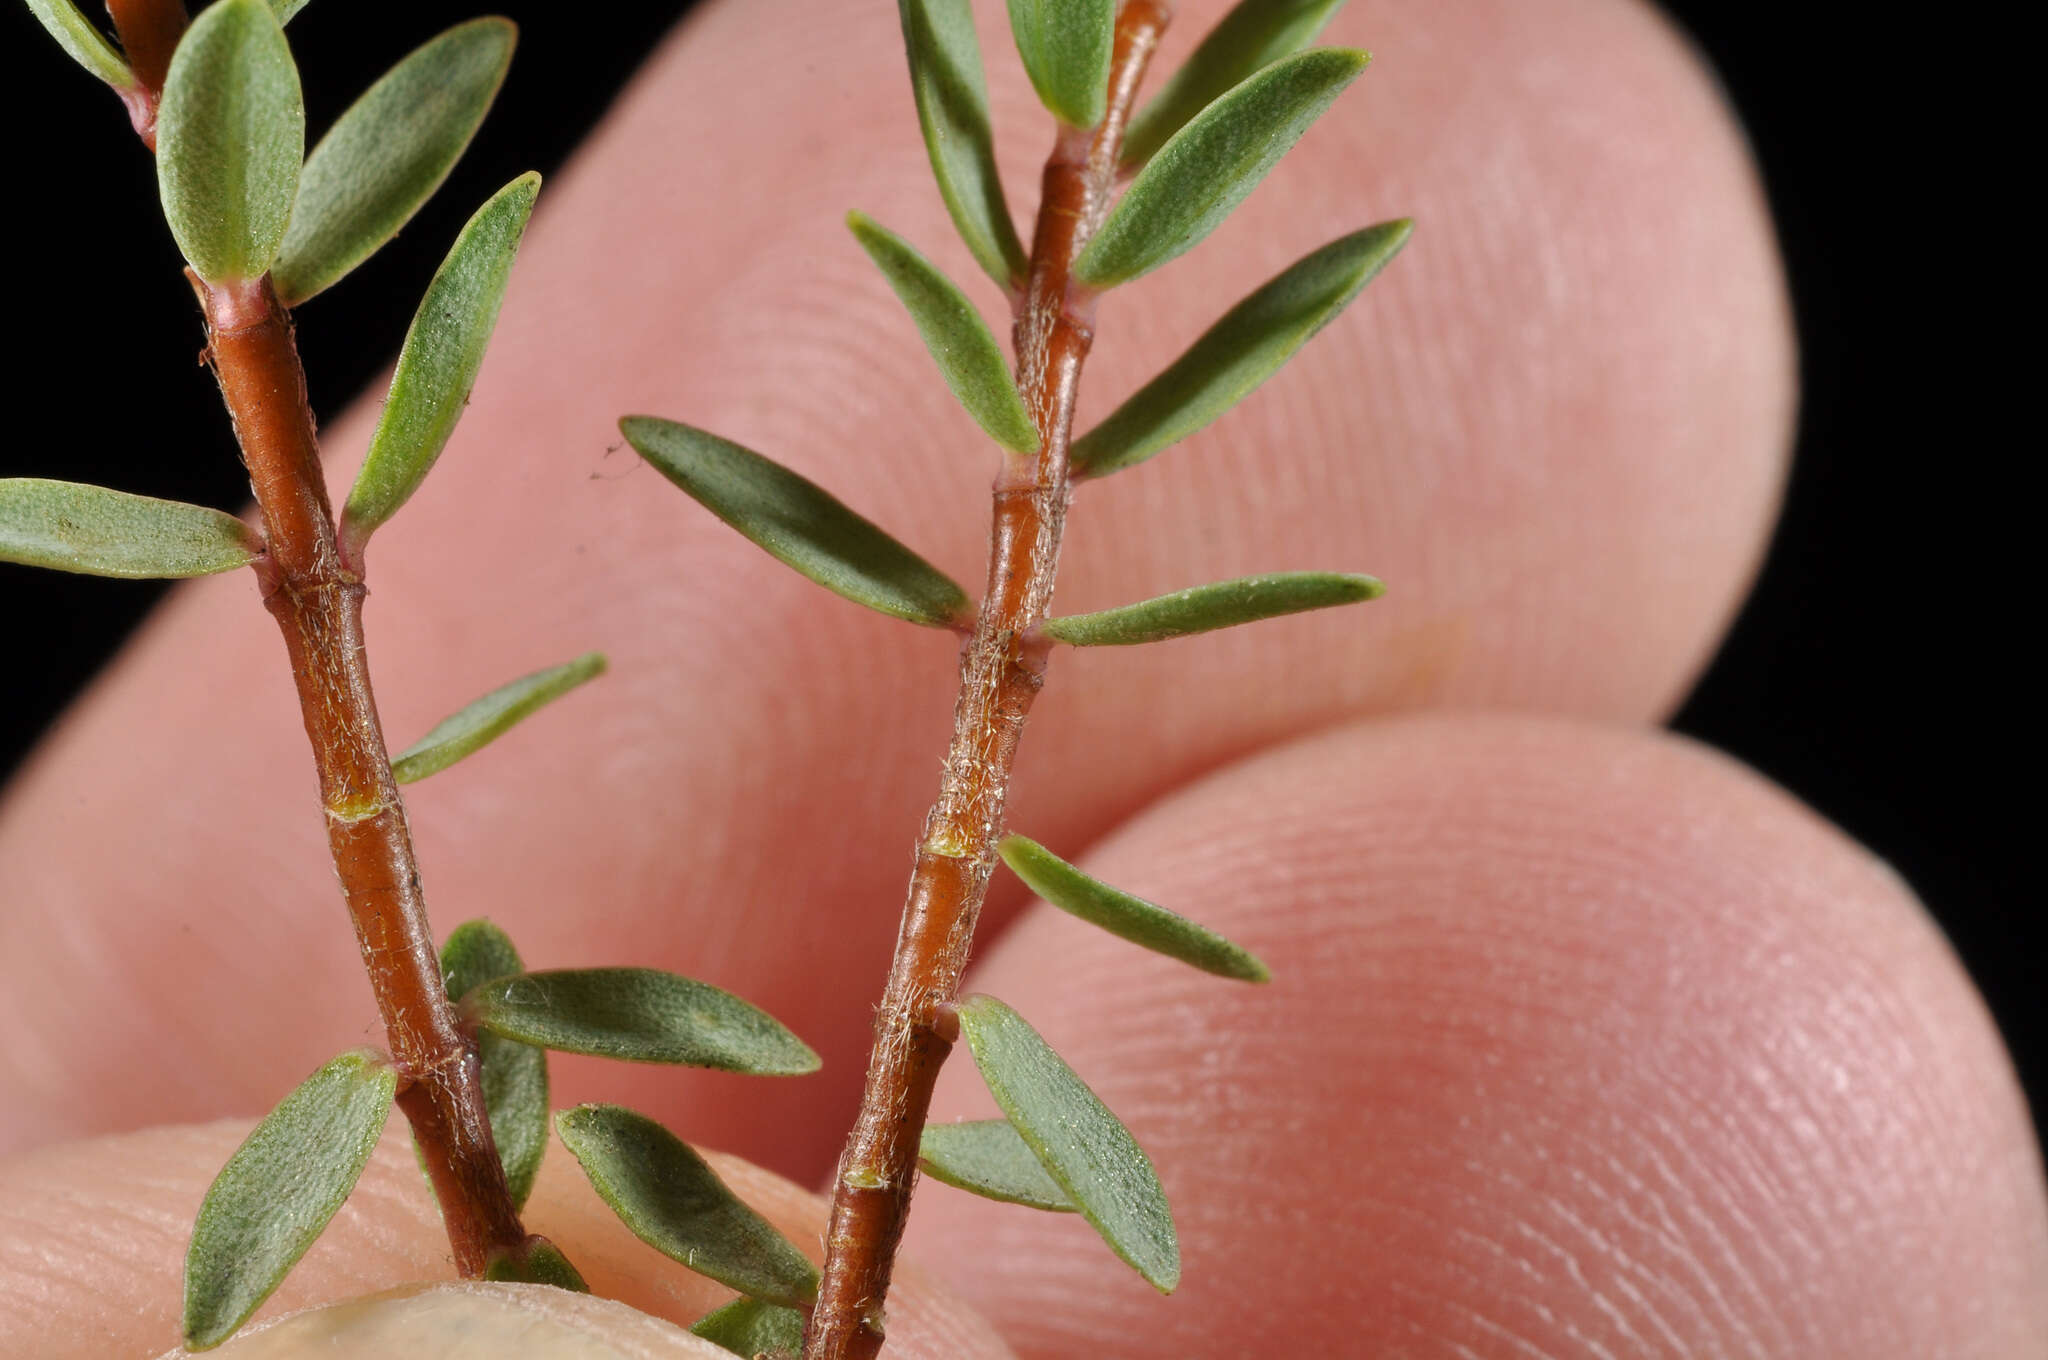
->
803, 0, 1171, 1360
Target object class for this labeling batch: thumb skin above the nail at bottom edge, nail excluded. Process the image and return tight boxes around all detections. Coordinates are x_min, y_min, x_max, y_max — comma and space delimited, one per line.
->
0, 1118, 1010, 1360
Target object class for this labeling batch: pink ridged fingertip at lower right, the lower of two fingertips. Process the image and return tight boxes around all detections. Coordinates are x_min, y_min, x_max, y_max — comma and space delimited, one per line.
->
909, 719, 2048, 1360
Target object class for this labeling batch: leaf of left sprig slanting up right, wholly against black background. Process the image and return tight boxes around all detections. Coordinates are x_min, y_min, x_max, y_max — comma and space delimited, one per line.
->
270, 18, 518, 305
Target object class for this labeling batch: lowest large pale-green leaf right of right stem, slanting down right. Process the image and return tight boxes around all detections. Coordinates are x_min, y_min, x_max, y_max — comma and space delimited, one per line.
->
958, 995, 1180, 1294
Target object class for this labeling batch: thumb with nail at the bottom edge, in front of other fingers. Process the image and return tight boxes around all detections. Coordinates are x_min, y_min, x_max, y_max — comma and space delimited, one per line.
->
0, 1120, 1012, 1360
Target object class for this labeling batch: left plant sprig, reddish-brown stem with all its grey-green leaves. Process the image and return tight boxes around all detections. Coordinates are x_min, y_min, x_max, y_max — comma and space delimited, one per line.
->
14, 0, 817, 1350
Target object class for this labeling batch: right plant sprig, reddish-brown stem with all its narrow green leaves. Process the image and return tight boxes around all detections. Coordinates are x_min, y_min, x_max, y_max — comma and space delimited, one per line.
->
621, 0, 1409, 1360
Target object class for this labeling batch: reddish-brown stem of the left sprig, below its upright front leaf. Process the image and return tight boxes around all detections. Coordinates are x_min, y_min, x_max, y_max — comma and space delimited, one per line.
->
195, 279, 526, 1276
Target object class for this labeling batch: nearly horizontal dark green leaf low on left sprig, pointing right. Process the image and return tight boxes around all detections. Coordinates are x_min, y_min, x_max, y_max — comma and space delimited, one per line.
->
463, 969, 817, 1077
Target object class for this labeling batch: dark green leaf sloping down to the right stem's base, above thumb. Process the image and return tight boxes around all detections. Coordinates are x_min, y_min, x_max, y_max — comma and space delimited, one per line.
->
555, 1104, 817, 1309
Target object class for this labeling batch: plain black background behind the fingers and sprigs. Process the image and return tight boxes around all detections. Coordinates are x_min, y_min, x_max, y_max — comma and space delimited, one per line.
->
0, 0, 2048, 1138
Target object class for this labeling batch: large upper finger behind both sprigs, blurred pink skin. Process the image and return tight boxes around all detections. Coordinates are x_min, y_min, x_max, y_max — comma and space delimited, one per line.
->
0, 0, 1792, 1176
